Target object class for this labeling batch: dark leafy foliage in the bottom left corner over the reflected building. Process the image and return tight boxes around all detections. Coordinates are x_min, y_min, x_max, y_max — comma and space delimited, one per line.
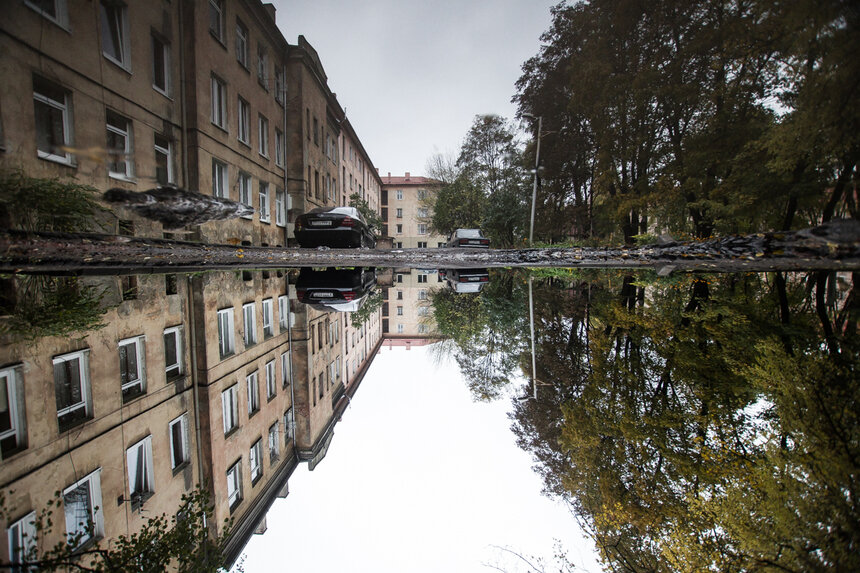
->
0, 490, 231, 573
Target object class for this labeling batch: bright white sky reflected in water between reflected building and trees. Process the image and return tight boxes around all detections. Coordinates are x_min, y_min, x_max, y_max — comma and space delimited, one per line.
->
235, 347, 599, 573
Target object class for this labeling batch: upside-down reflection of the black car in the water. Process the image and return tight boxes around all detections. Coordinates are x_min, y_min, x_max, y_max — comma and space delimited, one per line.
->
296, 267, 376, 312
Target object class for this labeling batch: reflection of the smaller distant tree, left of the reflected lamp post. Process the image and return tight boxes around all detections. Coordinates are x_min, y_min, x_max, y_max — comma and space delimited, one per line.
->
430, 274, 528, 400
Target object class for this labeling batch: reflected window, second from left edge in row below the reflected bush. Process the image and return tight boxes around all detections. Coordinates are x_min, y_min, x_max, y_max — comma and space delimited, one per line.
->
54, 350, 92, 432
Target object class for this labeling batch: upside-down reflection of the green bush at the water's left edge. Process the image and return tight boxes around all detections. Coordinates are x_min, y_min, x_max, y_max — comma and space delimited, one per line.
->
0, 275, 109, 341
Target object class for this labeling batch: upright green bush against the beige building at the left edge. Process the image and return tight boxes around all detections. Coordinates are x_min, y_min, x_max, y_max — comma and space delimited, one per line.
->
0, 170, 108, 233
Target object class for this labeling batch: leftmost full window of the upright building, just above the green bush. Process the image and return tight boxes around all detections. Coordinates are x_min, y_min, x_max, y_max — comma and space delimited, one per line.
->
33, 76, 72, 164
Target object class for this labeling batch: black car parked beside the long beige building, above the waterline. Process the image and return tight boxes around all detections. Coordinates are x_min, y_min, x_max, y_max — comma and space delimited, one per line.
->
295, 207, 376, 249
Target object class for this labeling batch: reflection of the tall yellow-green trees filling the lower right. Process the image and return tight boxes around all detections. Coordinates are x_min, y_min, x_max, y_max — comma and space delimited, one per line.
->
514, 274, 860, 571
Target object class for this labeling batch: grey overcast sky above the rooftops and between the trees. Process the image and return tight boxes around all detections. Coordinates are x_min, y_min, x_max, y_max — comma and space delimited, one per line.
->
274, 0, 557, 175
